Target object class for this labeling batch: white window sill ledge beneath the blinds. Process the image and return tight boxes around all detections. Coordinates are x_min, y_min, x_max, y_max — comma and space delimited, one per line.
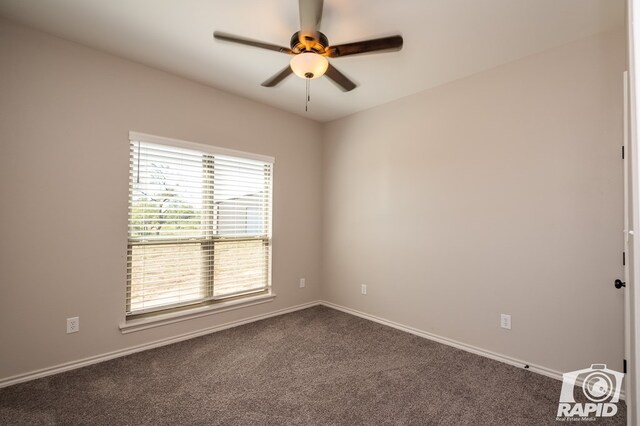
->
120, 293, 276, 334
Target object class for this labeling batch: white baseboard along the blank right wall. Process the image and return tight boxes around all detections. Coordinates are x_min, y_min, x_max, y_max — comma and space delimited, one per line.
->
320, 300, 625, 400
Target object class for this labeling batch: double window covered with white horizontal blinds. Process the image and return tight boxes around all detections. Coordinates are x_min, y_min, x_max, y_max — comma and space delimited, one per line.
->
126, 133, 273, 317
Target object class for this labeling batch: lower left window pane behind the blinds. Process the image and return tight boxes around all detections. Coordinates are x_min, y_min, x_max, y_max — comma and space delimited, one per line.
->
129, 243, 206, 312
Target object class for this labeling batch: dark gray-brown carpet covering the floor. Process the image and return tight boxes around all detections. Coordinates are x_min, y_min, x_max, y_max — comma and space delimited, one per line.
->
0, 307, 625, 425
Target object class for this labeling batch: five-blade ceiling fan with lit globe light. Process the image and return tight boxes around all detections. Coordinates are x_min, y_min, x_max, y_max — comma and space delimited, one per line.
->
213, 0, 402, 92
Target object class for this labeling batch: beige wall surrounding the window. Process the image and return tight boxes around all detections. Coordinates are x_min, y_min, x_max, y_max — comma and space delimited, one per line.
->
0, 20, 322, 379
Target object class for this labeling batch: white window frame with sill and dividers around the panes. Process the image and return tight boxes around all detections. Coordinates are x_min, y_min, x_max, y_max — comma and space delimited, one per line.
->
125, 131, 275, 322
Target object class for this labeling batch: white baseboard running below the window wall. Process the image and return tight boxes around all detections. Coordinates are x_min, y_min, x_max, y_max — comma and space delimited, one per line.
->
0, 301, 320, 388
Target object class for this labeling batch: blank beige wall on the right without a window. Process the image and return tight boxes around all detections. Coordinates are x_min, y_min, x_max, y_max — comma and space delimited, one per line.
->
322, 31, 625, 371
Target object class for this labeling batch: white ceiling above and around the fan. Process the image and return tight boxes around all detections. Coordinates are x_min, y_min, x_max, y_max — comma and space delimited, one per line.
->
0, 0, 625, 121
